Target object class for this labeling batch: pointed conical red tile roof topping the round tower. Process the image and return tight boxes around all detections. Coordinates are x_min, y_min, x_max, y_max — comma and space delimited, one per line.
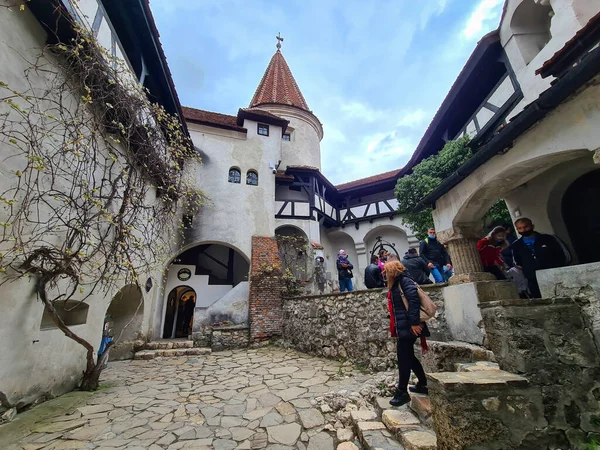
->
250, 50, 310, 111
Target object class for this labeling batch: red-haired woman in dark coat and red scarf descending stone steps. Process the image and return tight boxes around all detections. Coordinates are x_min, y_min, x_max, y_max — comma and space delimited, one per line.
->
385, 261, 429, 406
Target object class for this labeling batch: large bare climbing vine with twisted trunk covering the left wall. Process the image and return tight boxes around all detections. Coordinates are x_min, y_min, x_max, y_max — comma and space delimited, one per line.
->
0, 5, 204, 389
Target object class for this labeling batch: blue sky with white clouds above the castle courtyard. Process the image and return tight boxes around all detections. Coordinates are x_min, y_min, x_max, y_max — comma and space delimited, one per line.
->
150, 0, 503, 184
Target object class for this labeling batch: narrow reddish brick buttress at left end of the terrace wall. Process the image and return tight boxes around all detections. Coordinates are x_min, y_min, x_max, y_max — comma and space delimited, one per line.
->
248, 236, 283, 342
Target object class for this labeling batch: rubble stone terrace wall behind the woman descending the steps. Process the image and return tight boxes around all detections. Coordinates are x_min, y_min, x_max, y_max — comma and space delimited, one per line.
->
283, 285, 449, 370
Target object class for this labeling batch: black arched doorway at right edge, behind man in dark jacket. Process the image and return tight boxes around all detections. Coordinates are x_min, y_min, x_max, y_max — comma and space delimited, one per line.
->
562, 169, 600, 264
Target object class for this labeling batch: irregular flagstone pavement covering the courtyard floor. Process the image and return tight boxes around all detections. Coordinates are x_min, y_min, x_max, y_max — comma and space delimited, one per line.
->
8, 348, 376, 450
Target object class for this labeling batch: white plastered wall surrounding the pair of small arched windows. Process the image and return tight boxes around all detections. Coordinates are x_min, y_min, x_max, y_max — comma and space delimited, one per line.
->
187, 120, 281, 259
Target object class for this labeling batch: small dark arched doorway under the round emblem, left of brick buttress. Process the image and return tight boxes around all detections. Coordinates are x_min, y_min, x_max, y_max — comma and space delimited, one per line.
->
162, 285, 196, 339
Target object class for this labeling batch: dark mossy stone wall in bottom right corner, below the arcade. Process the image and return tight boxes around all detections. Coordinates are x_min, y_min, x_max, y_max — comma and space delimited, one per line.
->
481, 298, 600, 448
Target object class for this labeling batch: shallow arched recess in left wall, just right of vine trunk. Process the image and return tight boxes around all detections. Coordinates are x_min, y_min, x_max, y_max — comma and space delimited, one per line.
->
103, 284, 144, 361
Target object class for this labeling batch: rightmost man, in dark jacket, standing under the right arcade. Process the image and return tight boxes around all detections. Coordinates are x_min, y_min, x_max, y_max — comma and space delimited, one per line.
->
511, 217, 568, 298
